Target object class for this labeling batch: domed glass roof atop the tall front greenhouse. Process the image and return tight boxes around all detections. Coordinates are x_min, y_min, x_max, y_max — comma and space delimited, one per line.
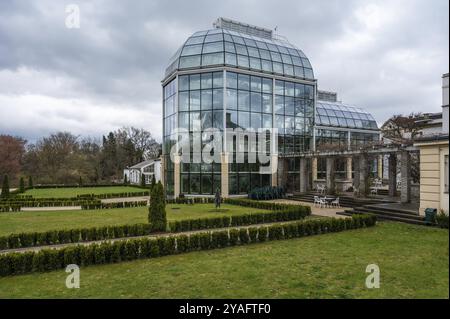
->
166, 28, 314, 79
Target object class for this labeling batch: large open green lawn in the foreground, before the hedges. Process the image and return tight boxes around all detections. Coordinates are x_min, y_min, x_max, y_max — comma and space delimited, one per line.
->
0, 222, 449, 298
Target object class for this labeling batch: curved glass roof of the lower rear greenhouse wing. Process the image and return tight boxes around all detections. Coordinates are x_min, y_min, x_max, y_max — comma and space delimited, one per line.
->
316, 101, 378, 130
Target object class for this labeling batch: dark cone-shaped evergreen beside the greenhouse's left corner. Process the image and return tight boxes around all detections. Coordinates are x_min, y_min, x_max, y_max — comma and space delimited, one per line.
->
148, 182, 167, 232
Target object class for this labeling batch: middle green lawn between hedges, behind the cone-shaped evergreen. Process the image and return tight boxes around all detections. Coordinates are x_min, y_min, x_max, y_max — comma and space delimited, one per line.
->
0, 204, 267, 236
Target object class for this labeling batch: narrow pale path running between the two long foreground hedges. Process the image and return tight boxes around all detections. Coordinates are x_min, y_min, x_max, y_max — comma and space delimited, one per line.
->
0, 216, 320, 255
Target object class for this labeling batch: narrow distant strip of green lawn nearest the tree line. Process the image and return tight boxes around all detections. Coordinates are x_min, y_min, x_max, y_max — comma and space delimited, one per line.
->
25, 186, 144, 198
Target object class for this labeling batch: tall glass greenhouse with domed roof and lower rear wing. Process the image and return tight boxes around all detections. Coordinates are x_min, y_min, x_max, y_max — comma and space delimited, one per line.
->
162, 18, 379, 197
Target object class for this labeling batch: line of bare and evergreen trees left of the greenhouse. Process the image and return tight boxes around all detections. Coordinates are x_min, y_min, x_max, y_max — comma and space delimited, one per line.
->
0, 127, 161, 187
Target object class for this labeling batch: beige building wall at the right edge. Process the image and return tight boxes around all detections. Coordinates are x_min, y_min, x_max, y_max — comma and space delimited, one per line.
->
418, 142, 448, 215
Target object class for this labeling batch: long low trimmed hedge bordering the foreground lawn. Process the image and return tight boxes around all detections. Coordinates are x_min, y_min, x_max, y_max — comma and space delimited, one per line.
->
0, 215, 376, 276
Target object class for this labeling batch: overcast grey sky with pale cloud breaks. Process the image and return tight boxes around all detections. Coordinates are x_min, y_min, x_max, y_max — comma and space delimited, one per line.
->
0, 0, 449, 141
